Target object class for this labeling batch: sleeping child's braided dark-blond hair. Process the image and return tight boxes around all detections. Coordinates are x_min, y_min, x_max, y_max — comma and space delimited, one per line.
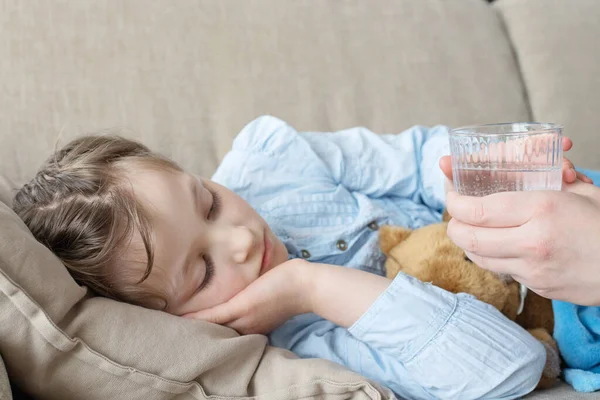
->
13, 136, 181, 309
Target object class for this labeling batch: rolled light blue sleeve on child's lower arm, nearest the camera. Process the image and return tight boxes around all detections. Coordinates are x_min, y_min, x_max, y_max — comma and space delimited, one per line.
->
272, 274, 546, 400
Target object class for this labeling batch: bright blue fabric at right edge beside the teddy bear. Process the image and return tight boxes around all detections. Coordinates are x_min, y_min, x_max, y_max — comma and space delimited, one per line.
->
553, 169, 600, 392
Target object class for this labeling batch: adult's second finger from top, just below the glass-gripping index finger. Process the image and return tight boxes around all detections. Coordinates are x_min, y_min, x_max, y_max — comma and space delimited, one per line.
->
448, 219, 528, 258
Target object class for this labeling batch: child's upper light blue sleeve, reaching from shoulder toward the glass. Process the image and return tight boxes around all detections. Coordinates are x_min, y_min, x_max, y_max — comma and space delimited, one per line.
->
213, 116, 448, 210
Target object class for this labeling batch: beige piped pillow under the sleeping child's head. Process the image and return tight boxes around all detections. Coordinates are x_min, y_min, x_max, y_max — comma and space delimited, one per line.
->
0, 197, 393, 400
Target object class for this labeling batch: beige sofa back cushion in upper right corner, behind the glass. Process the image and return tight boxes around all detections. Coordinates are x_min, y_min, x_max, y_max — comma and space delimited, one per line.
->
496, 0, 600, 169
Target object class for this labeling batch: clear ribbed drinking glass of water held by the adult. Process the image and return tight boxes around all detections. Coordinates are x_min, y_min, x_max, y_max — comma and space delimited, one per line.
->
450, 122, 562, 196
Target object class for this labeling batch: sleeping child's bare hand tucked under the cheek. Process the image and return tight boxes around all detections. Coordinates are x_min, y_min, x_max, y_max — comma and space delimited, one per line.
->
184, 260, 312, 335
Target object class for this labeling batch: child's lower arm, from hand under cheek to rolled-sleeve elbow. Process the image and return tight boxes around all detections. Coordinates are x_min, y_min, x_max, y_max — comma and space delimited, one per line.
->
190, 260, 545, 400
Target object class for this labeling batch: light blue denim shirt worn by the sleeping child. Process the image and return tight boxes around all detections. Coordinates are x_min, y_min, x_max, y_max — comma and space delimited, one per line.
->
213, 116, 545, 400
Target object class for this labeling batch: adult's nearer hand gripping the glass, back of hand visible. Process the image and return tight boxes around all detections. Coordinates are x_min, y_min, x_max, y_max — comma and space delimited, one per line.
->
447, 182, 600, 305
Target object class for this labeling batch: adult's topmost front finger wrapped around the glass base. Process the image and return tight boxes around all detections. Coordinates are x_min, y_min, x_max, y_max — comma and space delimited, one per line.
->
446, 192, 552, 228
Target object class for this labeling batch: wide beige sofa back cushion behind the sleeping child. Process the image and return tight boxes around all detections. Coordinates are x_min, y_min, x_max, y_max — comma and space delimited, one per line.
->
0, 0, 529, 184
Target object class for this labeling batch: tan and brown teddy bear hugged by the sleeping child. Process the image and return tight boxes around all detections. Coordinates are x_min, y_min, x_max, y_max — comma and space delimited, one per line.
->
379, 212, 560, 389
